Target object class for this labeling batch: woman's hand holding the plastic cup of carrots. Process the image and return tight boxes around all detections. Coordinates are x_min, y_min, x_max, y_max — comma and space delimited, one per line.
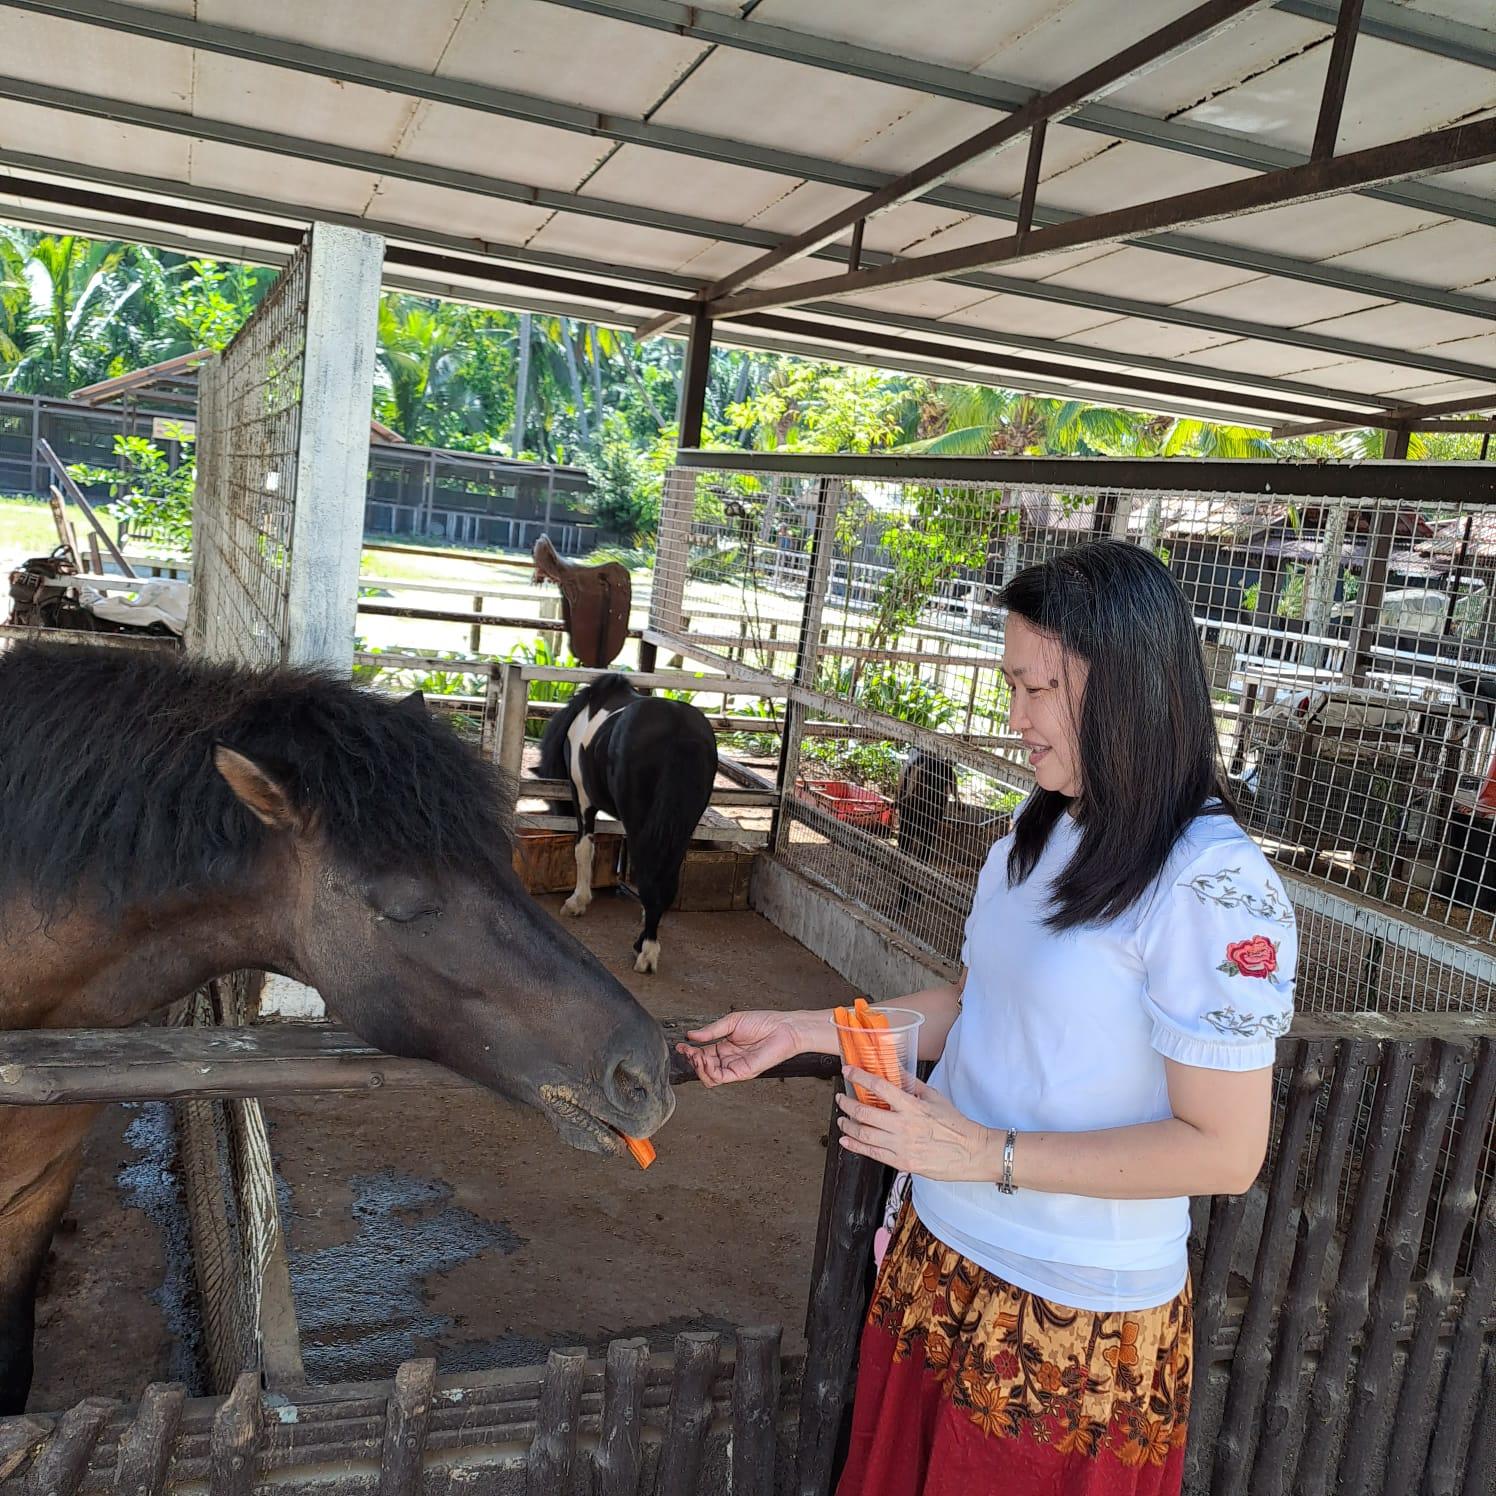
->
836, 1070, 1001, 1183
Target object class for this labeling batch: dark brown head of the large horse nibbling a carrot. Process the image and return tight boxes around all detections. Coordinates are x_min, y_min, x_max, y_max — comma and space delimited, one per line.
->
214, 693, 673, 1152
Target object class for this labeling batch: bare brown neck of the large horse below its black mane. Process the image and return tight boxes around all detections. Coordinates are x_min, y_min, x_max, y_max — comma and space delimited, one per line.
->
0, 895, 283, 1028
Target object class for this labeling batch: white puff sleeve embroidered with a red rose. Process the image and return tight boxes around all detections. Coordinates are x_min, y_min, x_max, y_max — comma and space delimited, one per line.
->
1138, 842, 1299, 1070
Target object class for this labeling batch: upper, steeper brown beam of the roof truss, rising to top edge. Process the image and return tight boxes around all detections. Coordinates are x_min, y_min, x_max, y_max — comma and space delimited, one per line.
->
702, 0, 1267, 302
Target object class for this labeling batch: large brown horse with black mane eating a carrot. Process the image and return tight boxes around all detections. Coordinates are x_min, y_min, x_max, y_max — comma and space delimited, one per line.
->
0, 643, 673, 1414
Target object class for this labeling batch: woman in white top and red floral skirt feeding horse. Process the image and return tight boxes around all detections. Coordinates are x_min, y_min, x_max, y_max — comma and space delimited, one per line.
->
682, 542, 1296, 1496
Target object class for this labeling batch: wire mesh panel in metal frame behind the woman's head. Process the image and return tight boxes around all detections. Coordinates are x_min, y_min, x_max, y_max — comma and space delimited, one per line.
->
651, 468, 1496, 1011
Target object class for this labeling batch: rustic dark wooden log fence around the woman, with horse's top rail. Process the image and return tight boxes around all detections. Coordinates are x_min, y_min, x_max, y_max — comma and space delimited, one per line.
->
0, 1014, 1496, 1496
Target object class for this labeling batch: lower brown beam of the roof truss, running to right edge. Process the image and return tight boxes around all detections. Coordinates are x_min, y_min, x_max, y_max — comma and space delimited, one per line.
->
708, 118, 1496, 317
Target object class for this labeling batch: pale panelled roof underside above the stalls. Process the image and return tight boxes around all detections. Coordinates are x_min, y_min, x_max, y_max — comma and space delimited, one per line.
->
0, 0, 1496, 422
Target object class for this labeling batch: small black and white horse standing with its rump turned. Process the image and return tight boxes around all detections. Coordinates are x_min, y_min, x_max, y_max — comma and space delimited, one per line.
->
540, 675, 717, 971
